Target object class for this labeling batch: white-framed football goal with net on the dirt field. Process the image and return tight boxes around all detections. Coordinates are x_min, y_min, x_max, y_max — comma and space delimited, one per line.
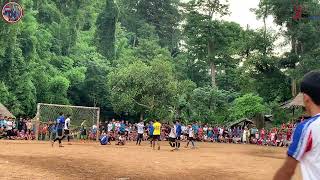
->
35, 103, 100, 140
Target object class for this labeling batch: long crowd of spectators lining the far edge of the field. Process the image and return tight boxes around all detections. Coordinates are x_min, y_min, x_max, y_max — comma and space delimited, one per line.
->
0, 114, 296, 147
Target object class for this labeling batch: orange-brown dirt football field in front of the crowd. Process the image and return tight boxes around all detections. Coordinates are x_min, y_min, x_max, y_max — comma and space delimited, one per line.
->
0, 141, 301, 180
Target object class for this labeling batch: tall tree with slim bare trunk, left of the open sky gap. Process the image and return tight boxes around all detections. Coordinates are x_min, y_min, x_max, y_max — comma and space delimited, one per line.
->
184, 0, 242, 87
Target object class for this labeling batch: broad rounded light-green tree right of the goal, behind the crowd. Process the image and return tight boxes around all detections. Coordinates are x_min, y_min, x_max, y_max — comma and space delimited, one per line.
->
108, 60, 176, 121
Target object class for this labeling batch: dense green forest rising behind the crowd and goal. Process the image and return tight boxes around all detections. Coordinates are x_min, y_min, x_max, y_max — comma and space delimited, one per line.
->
0, 0, 320, 123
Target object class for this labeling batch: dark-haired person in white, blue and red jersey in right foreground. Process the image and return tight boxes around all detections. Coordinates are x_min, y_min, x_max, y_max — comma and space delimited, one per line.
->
274, 71, 320, 180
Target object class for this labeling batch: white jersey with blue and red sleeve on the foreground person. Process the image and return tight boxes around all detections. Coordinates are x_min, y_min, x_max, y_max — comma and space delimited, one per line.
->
288, 114, 320, 180
